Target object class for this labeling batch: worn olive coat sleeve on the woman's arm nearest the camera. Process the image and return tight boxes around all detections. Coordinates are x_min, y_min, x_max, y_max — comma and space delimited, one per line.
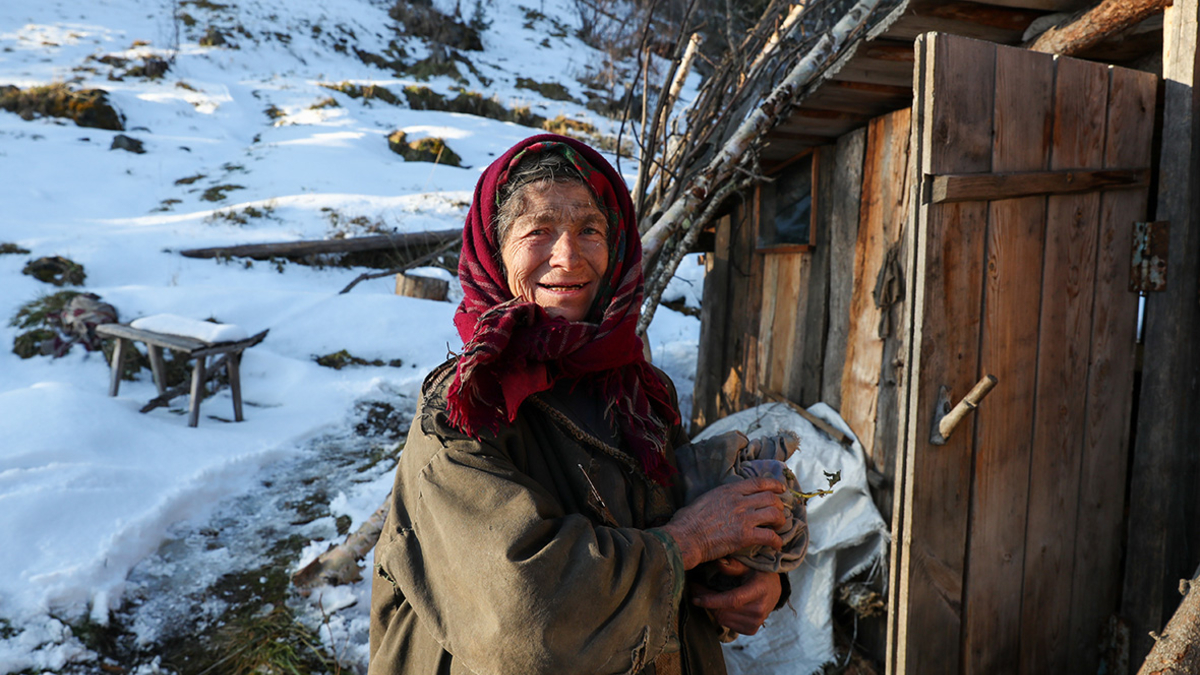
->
376, 401, 683, 674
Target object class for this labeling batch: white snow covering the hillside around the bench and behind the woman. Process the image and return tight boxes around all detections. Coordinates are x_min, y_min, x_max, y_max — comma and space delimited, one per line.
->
0, 0, 703, 673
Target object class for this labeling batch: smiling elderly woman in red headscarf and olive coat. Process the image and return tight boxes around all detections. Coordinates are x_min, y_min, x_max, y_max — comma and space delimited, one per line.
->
371, 135, 785, 675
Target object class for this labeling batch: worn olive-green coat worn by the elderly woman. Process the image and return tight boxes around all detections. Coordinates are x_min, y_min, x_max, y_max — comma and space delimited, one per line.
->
370, 362, 725, 675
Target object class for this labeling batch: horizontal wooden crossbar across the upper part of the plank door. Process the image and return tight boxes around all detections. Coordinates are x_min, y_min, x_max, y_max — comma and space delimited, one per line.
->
930, 169, 1150, 204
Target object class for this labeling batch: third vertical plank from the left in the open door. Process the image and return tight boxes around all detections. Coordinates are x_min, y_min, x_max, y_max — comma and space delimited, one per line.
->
1020, 58, 1109, 674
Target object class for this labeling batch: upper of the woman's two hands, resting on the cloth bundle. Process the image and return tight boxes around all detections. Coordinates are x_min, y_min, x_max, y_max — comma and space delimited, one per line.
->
662, 477, 786, 569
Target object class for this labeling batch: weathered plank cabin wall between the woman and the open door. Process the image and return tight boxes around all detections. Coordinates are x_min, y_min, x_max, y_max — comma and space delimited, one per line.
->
692, 109, 911, 518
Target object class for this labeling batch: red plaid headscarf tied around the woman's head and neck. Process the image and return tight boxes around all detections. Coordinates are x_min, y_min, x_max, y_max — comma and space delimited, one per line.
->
448, 133, 679, 484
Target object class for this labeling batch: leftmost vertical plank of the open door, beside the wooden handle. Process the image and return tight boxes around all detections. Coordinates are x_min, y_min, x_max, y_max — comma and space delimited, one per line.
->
895, 34, 996, 674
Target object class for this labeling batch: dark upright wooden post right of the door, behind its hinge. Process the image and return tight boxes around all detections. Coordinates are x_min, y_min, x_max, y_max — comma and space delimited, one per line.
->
1122, 0, 1200, 667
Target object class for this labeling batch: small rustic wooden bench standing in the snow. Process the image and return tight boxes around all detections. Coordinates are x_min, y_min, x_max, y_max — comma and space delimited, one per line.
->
96, 323, 268, 426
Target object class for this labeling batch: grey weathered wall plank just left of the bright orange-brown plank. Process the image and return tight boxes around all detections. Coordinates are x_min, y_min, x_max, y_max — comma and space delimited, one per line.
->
821, 129, 866, 411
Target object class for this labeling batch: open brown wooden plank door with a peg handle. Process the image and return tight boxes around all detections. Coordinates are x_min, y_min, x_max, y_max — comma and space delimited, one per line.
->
888, 34, 1157, 674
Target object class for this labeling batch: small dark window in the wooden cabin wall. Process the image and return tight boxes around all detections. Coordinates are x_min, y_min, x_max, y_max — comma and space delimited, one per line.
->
758, 151, 817, 252
